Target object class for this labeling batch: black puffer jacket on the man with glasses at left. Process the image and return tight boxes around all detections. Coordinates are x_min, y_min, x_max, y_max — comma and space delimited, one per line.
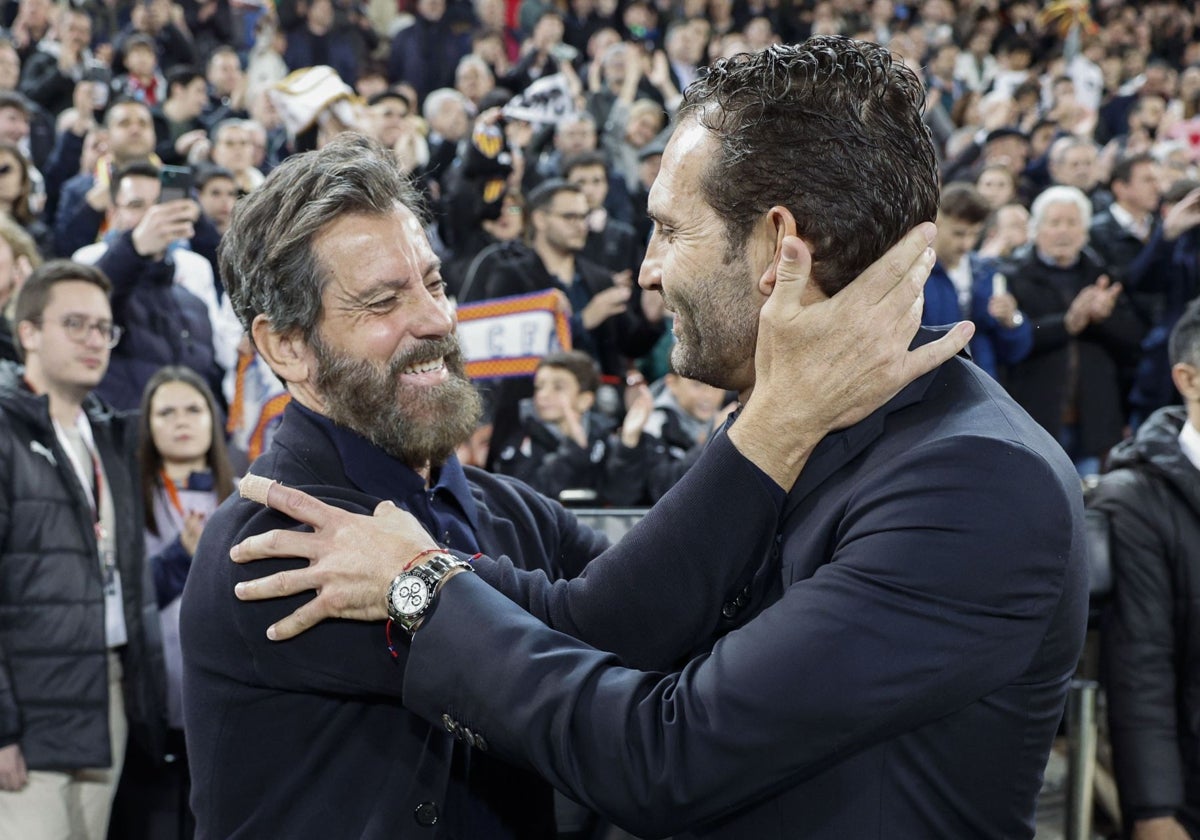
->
0, 362, 166, 770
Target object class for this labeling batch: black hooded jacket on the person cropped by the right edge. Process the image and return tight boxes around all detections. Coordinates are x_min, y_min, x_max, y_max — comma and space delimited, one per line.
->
1090, 407, 1200, 836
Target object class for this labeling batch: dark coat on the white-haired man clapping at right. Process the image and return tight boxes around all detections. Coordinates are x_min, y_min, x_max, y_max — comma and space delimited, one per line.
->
1001, 248, 1146, 455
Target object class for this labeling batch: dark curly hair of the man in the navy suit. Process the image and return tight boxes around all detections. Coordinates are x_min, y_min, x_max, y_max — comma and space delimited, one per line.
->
679, 36, 937, 295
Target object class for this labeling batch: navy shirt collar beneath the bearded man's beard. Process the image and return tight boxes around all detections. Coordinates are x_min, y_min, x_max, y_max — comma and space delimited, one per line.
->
292, 400, 479, 529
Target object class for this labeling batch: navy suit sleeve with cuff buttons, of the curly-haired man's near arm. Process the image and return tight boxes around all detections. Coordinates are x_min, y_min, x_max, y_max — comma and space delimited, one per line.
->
404, 439, 1082, 836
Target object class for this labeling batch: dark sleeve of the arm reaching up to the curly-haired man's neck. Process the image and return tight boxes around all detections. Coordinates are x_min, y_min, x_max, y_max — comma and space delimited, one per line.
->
475, 434, 782, 668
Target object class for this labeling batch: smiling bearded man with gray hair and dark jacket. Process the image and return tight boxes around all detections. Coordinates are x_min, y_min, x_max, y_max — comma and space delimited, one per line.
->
181, 136, 590, 839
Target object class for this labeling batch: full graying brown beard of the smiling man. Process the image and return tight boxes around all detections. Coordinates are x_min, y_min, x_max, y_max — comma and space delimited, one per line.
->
311, 334, 482, 469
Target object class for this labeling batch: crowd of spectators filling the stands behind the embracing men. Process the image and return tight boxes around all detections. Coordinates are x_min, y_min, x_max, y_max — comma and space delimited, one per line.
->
0, 0, 1200, 835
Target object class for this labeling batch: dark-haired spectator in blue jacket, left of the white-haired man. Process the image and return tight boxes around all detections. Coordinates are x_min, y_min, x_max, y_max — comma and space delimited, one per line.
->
920, 184, 1033, 379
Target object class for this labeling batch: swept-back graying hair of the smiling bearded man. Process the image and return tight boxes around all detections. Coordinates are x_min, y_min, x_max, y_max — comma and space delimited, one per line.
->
218, 132, 425, 340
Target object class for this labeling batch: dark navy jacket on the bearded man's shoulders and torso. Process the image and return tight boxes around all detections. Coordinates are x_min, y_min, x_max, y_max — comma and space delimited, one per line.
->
181, 403, 607, 840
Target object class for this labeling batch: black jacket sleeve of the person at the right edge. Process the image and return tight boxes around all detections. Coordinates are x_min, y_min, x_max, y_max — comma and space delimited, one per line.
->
1092, 470, 1187, 821
